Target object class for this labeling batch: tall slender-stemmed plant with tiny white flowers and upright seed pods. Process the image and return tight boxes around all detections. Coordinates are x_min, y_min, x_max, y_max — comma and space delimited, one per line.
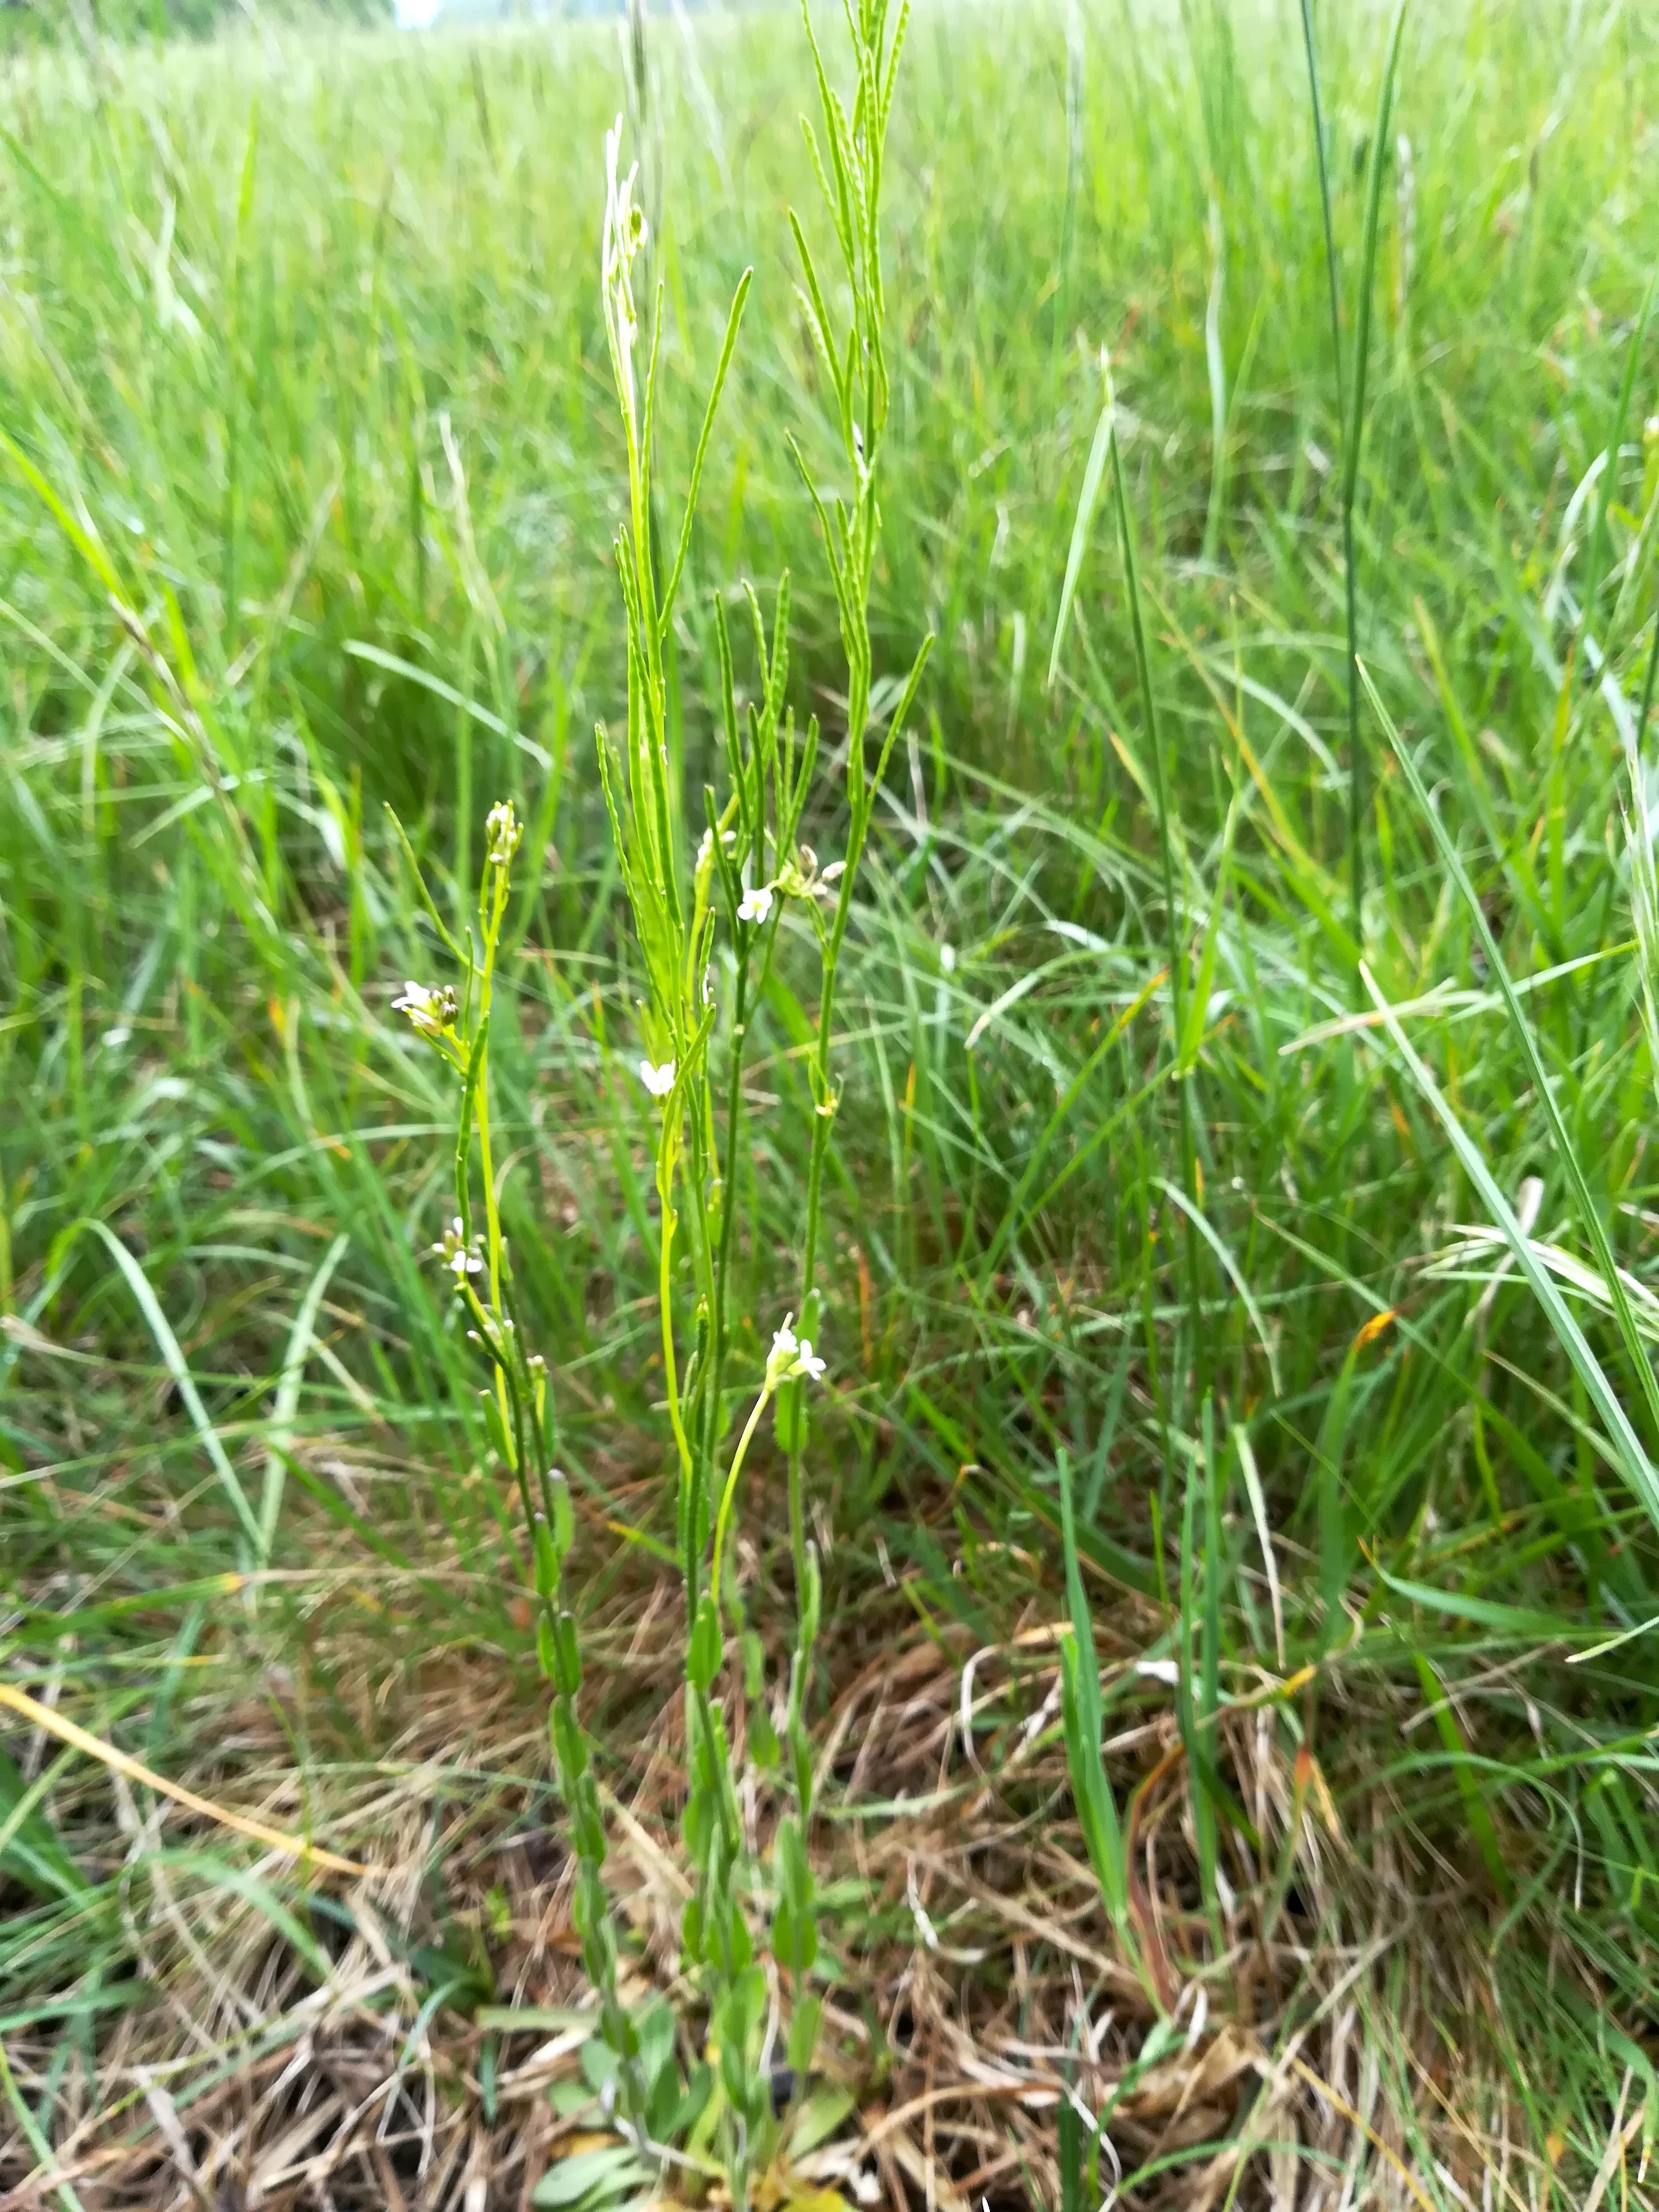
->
369, 0, 927, 2159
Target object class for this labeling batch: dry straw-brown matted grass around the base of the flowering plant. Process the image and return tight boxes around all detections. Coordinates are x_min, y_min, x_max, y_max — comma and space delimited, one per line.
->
0, 1469, 1565, 2212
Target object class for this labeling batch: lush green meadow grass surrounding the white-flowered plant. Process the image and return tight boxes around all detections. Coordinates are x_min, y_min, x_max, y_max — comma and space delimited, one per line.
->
0, 0, 1659, 2212
